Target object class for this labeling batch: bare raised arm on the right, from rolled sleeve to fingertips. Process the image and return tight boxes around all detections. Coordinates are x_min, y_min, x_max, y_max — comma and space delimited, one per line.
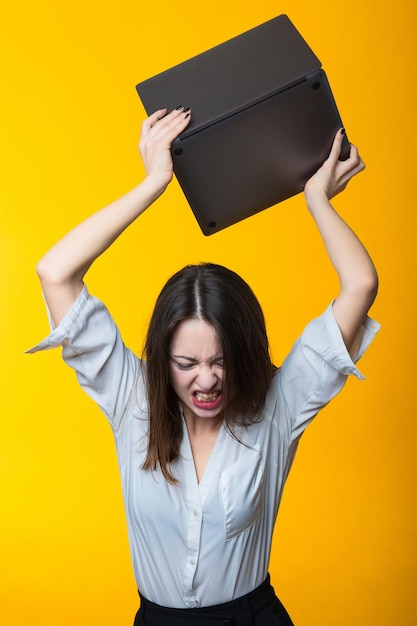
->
304, 130, 378, 351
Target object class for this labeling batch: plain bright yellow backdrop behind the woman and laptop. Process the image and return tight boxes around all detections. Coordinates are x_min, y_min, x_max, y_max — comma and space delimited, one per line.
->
0, 0, 417, 626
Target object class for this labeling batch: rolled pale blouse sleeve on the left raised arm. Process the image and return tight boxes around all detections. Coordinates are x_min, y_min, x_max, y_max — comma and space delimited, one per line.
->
27, 286, 140, 429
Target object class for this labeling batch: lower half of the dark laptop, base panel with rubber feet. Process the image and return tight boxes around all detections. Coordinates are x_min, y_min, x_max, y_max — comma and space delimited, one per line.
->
172, 70, 349, 235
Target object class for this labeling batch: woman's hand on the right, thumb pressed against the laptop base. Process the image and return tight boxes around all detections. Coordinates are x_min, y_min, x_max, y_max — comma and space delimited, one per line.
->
304, 129, 365, 200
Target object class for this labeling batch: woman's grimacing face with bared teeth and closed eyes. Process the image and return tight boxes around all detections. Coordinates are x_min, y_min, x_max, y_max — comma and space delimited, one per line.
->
169, 318, 224, 419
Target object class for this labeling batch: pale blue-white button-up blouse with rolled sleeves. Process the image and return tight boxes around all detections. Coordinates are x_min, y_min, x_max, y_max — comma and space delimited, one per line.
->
28, 287, 379, 608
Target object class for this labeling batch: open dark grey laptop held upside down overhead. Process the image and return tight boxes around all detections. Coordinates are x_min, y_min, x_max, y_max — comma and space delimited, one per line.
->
136, 15, 349, 235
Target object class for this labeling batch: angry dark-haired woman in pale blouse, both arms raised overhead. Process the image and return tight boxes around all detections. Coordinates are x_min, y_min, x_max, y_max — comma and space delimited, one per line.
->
32, 107, 378, 626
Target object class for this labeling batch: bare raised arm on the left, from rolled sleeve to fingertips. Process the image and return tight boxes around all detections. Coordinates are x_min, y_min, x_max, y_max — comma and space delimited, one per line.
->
36, 107, 190, 324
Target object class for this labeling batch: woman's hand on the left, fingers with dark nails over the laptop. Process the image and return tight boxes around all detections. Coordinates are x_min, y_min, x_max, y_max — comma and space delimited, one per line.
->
139, 106, 191, 189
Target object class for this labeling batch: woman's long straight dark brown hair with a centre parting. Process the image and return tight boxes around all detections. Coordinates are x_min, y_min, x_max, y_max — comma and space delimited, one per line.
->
143, 263, 276, 483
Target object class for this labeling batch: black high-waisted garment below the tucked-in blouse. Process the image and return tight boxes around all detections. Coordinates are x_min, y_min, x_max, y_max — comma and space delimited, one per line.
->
134, 575, 294, 626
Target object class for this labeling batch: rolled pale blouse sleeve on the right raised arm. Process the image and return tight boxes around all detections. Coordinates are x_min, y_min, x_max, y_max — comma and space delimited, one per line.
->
276, 304, 380, 440
